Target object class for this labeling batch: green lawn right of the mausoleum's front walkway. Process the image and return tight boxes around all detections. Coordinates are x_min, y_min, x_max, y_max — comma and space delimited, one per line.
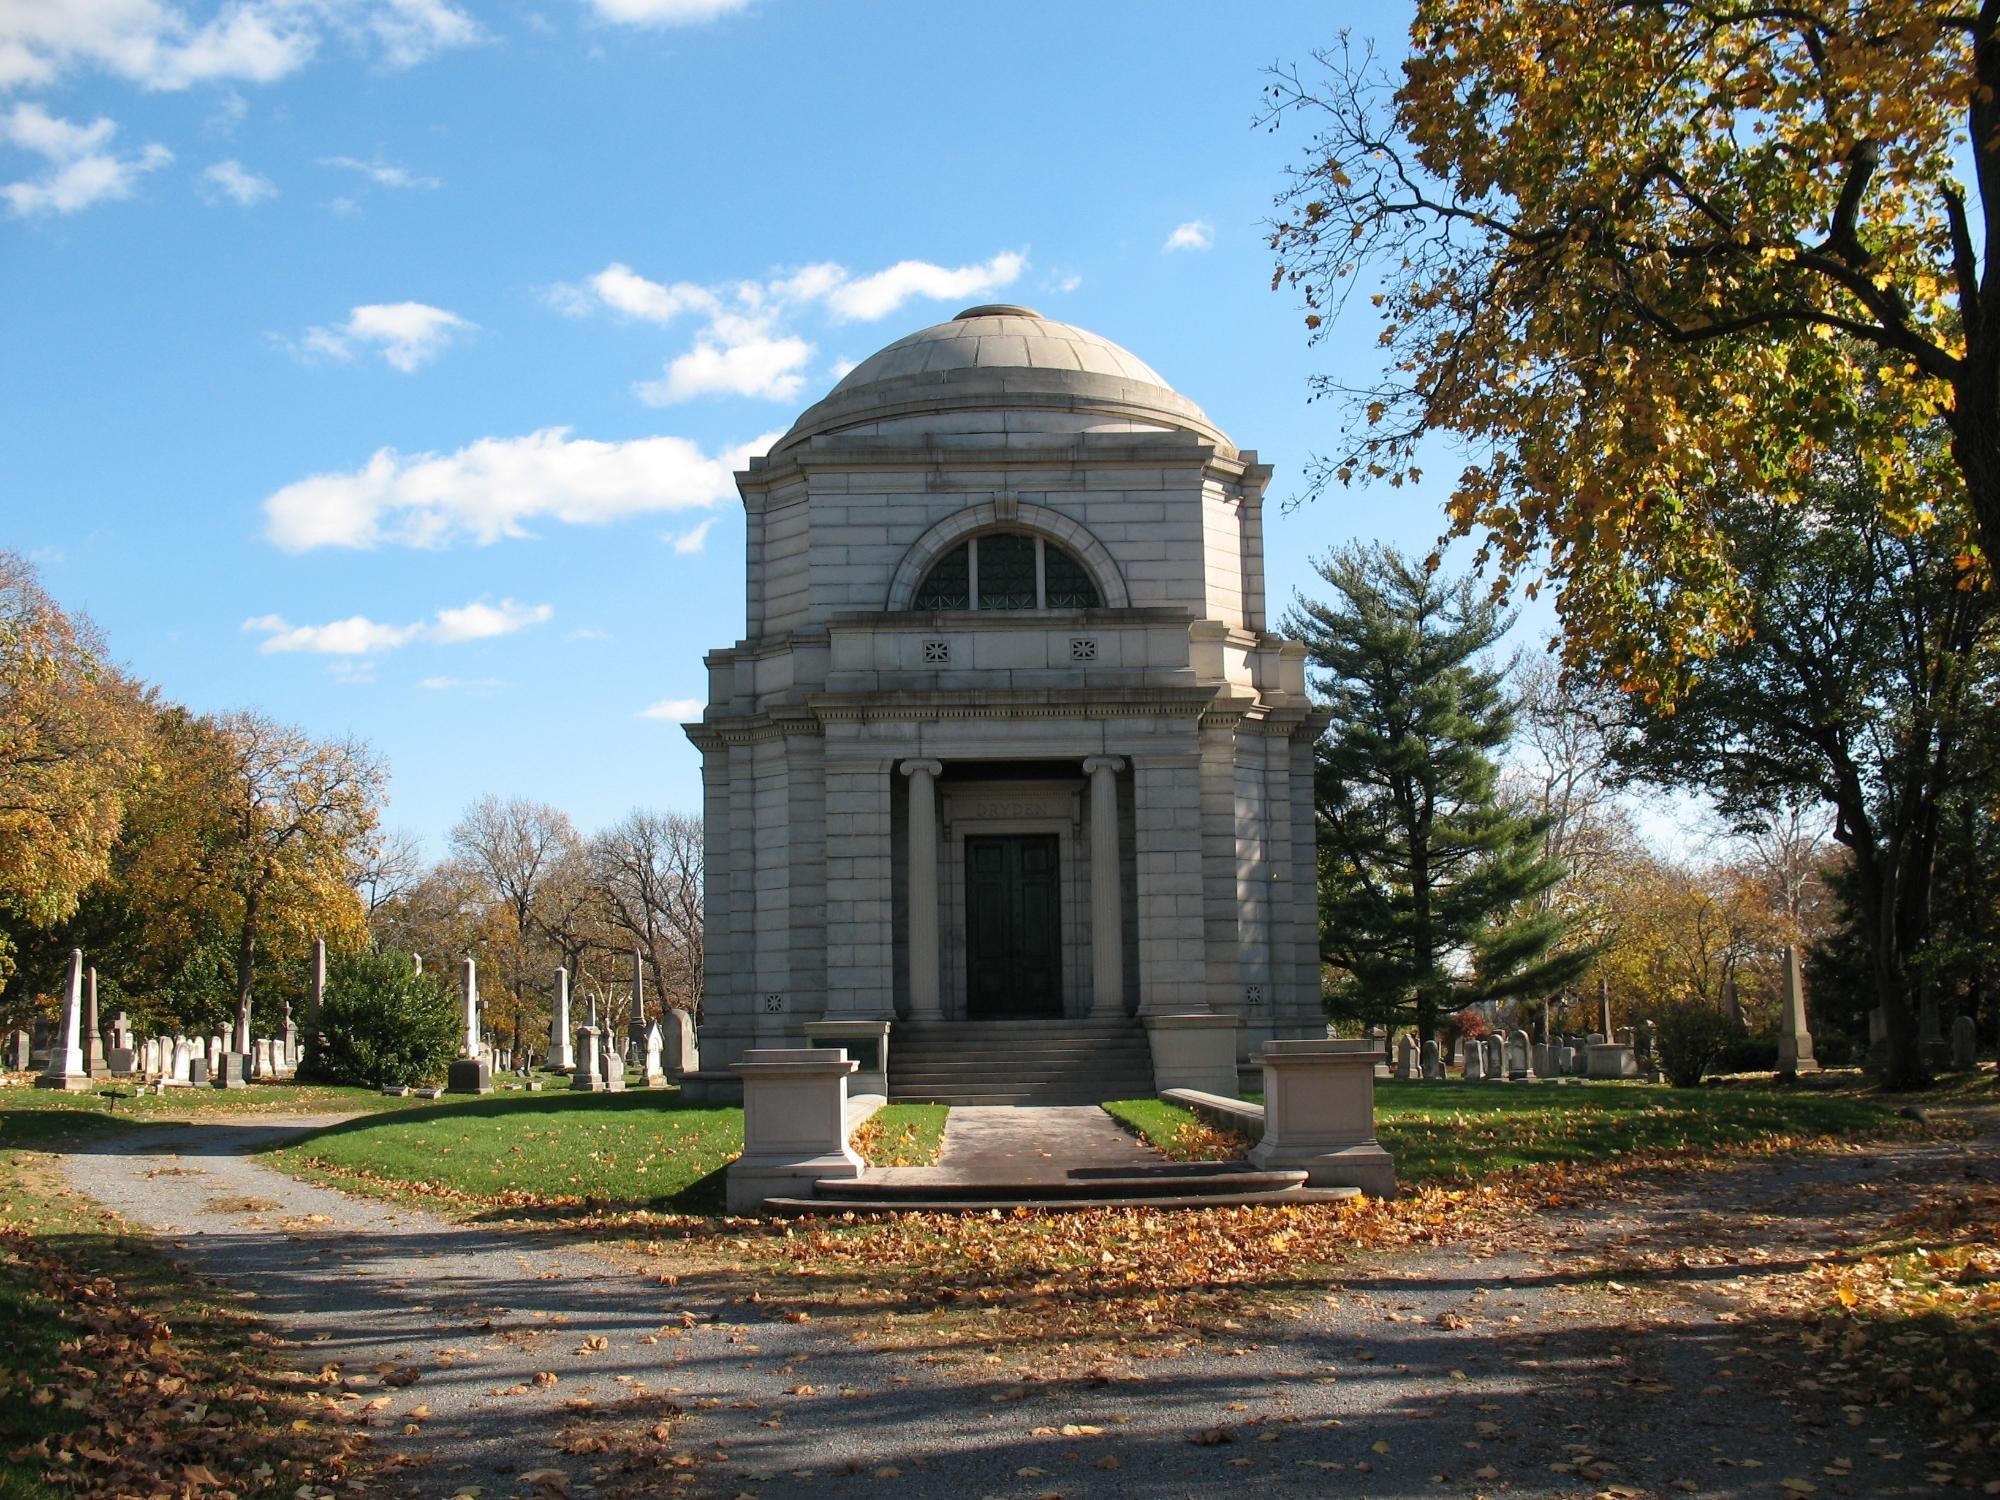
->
1104, 1082, 1896, 1182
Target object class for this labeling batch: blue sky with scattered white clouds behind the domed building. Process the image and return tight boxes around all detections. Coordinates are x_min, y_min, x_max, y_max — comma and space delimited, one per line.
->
0, 0, 1504, 850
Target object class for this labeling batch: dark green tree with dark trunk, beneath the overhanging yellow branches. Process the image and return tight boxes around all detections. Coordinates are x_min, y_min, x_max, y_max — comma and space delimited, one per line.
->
1620, 440, 1996, 1088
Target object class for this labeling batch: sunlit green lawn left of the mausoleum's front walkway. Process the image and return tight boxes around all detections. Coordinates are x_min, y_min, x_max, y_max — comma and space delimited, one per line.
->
270, 1090, 944, 1214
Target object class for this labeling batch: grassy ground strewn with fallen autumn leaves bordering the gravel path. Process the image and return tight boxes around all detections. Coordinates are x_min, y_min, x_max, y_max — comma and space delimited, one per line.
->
0, 1078, 2000, 1494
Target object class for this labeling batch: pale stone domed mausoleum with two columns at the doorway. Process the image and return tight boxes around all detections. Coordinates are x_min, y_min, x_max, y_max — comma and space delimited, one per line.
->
688, 306, 1324, 1102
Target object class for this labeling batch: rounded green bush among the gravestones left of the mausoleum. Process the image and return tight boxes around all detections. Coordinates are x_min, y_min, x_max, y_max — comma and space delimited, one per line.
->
298, 952, 464, 1088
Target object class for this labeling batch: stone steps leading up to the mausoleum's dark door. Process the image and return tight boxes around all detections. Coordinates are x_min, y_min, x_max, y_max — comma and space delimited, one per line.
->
888, 1018, 1152, 1104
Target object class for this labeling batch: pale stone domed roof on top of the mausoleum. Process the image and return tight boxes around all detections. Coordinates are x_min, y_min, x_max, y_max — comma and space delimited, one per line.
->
772, 302, 1234, 454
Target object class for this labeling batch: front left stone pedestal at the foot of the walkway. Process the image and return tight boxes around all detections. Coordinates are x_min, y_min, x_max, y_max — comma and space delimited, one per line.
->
728, 1046, 864, 1214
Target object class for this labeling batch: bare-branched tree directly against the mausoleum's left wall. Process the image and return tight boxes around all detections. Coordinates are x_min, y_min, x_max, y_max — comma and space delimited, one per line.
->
590, 810, 702, 1014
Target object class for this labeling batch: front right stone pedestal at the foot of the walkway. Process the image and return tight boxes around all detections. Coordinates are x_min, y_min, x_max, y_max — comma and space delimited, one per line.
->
1250, 1040, 1396, 1198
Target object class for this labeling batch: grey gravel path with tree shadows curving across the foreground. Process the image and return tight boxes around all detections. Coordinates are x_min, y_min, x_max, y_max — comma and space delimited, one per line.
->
50, 1122, 1996, 1500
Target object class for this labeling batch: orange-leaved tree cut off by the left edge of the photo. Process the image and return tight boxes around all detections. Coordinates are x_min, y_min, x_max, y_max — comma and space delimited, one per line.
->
0, 552, 146, 988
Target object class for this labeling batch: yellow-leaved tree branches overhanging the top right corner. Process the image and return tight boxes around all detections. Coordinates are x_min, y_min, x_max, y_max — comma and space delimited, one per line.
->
1266, 0, 2000, 694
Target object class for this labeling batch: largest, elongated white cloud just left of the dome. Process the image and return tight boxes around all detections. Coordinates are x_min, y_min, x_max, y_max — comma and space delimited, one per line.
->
264, 428, 778, 552
